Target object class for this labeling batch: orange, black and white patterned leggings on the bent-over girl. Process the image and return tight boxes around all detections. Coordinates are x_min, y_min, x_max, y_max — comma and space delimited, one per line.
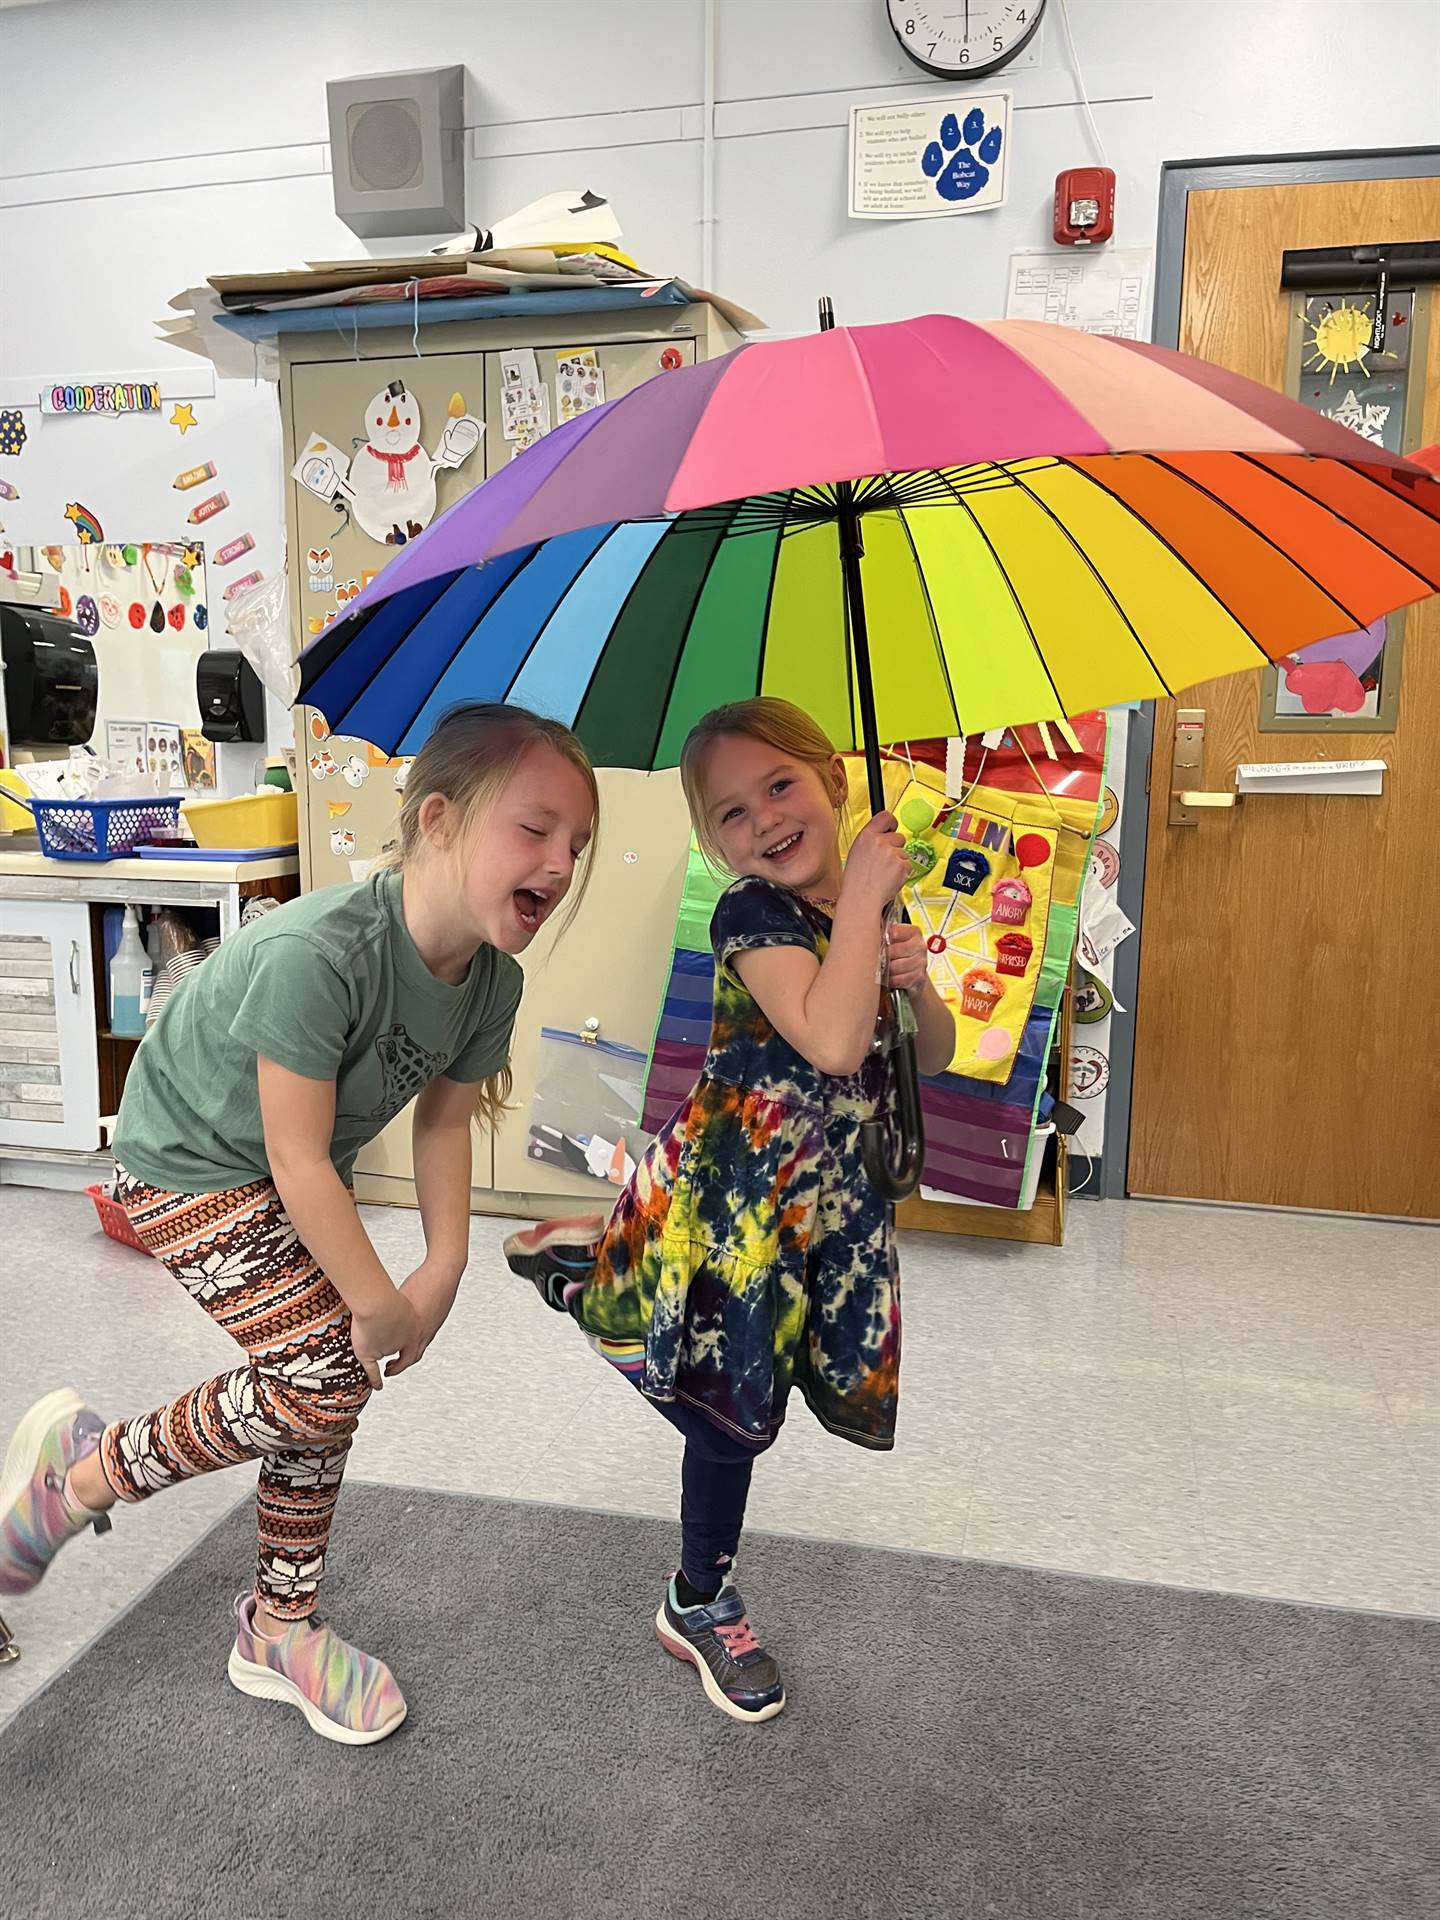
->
100, 1167, 371, 1620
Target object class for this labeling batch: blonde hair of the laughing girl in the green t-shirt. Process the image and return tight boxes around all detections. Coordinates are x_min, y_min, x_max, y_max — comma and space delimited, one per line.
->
386, 701, 599, 1129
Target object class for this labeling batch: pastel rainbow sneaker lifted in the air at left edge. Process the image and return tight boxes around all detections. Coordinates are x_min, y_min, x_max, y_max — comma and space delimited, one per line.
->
0, 1386, 109, 1594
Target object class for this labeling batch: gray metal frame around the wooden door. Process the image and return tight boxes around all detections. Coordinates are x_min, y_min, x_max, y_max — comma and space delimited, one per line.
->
1083, 146, 1440, 1200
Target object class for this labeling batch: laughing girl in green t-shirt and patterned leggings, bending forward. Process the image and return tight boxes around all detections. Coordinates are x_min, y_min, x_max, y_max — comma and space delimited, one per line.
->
0, 705, 597, 1745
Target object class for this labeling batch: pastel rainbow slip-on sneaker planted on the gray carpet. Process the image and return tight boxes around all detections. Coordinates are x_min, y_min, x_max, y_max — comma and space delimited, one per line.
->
228, 1592, 405, 1747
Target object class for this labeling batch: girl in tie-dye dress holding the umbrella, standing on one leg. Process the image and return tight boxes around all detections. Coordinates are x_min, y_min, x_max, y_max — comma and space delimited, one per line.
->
505, 699, 954, 1720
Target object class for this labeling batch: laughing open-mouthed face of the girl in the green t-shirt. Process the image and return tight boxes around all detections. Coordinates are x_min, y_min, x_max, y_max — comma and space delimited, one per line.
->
459, 741, 595, 954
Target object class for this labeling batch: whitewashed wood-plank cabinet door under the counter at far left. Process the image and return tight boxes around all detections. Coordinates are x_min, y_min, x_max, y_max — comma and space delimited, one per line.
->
0, 900, 100, 1152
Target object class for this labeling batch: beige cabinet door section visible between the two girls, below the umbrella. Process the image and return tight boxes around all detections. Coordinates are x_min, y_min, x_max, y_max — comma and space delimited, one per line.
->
495, 768, 689, 1210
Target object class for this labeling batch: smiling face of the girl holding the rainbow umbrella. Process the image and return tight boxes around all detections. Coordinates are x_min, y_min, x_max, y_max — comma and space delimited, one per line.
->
705, 733, 845, 893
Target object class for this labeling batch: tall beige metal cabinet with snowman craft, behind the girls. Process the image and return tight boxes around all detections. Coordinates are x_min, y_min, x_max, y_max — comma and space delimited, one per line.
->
280, 305, 739, 1206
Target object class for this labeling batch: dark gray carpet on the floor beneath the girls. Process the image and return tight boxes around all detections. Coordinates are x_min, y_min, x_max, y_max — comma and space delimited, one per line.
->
0, 1484, 1440, 1920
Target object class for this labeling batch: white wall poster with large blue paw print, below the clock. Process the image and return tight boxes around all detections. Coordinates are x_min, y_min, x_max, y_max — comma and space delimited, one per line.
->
851, 92, 1012, 221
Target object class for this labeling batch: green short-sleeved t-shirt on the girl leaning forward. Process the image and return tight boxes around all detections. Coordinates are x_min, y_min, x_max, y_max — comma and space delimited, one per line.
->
115, 872, 522, 1192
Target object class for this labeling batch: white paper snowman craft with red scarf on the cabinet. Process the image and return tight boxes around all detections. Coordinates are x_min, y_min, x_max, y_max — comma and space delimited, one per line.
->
290, 380, 484, 547
